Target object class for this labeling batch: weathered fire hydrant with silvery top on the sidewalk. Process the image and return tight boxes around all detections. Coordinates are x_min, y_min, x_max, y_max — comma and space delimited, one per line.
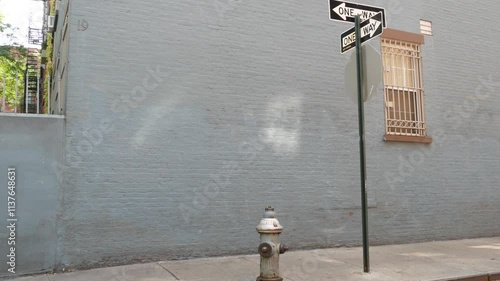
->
257, 206, 288, 281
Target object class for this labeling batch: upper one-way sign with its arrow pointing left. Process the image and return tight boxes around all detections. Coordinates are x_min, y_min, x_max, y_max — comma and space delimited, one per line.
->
330, 0, 387, 28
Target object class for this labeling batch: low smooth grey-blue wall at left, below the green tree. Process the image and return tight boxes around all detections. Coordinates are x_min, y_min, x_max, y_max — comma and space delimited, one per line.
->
0, 114, 65, 277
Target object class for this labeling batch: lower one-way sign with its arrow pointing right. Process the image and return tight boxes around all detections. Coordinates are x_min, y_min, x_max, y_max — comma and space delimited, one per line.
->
340, 13, 383, 54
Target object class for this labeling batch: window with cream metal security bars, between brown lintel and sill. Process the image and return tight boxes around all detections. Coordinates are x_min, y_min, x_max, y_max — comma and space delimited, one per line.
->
381, 38, 427, 137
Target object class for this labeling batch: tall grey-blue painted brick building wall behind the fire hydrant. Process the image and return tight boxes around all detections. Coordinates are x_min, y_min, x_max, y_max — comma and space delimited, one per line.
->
58, 0, 500, 267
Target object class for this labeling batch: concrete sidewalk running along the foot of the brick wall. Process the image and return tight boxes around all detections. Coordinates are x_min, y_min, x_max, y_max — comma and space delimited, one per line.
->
10, 237, 500, 281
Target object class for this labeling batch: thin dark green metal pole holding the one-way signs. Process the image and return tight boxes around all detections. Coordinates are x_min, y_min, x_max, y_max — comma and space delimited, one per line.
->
354, 16, 370, 272
